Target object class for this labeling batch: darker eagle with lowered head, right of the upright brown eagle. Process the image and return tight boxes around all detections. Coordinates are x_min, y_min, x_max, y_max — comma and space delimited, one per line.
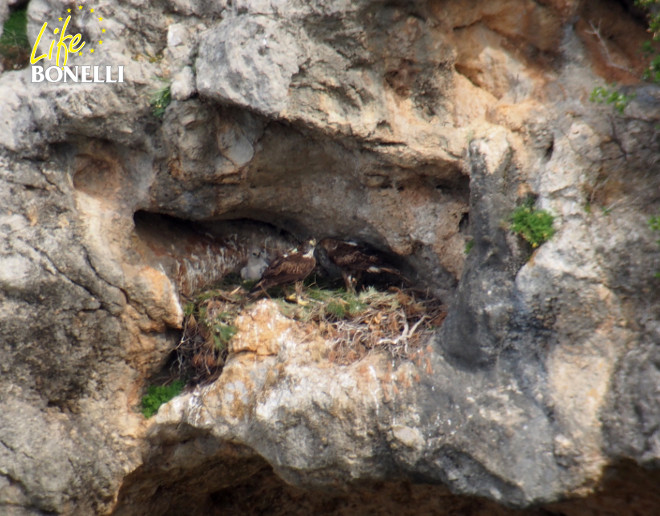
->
316, 238, 402, 292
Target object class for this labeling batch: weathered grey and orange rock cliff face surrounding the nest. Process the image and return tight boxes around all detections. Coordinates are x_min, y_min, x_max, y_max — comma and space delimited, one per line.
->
0, 0, 660, 514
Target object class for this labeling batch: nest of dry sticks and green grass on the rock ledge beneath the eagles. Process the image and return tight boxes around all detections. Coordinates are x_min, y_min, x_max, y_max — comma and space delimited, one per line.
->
173, 278, 447, 384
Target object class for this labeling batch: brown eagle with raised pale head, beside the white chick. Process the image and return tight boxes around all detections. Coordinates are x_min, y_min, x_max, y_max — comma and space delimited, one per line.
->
250, 240, 316, 299
